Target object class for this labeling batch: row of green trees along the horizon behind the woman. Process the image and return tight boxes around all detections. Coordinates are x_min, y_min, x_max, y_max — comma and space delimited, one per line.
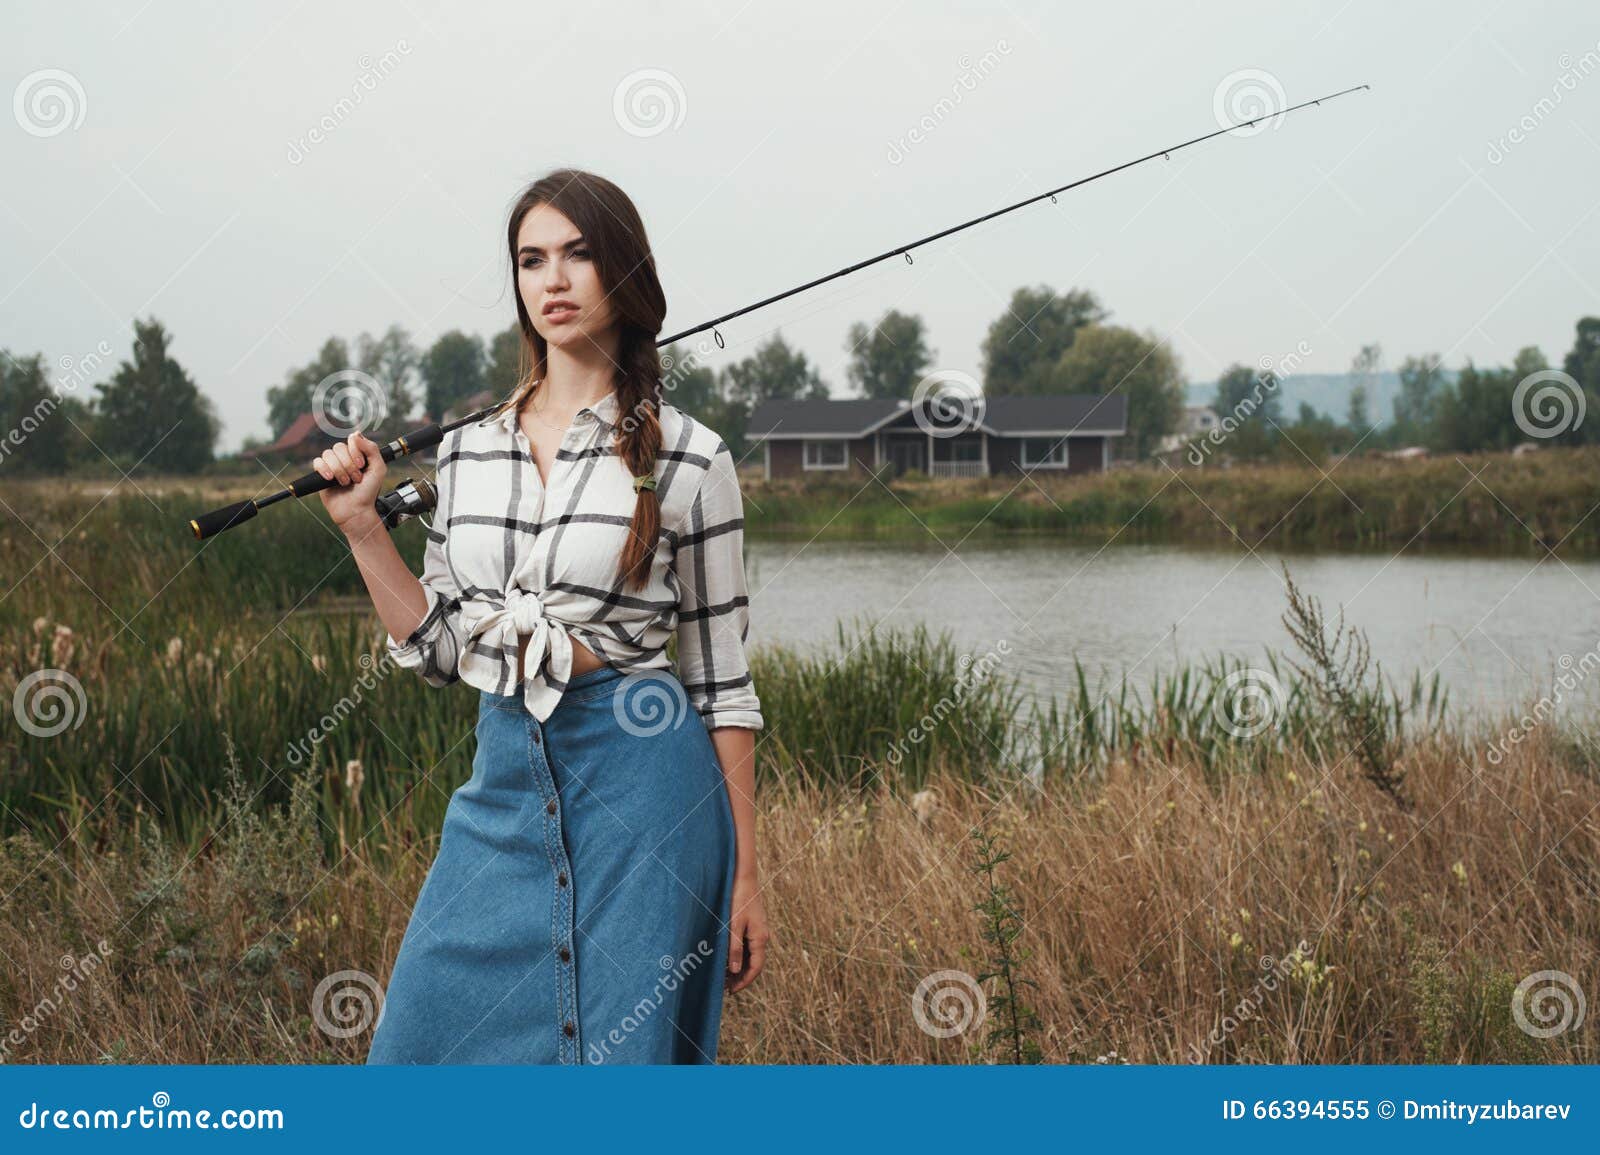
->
0, 294, 1600, 475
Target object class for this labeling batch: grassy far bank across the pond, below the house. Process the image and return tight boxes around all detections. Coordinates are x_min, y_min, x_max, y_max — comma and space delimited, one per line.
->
744, 446, 1600, 554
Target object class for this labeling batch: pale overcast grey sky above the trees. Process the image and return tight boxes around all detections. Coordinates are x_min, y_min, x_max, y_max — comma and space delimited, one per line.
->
0, 0, 1600, 451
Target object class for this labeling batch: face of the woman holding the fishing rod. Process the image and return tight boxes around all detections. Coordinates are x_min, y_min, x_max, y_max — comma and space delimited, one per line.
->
517, 205, 613, 346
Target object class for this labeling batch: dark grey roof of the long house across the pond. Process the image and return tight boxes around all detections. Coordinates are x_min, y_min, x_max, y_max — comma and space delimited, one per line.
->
744, 394, 1128, 440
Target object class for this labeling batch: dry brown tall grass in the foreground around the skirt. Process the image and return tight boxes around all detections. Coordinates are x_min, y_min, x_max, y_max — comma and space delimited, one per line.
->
0, 723, 1600, 1064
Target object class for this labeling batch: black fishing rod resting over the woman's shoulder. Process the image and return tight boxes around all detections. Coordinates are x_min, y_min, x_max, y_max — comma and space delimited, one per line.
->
189, 85, 1371, 539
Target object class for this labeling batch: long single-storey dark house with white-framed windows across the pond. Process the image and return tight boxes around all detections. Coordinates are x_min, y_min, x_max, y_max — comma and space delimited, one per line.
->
744, 394, 1128, 480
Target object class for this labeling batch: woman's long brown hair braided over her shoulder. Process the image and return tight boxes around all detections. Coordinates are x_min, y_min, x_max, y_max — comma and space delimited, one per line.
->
494, 168, 667, 589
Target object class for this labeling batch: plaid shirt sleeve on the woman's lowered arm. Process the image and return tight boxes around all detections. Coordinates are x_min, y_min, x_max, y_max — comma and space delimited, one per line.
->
672, 442, 765, 731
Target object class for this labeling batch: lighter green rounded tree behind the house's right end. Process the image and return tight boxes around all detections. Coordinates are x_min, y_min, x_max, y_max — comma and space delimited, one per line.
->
1046, 325, 1184, 458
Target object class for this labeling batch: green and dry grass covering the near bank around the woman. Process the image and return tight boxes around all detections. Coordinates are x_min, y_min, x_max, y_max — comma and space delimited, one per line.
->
0, 473, 1600, 1062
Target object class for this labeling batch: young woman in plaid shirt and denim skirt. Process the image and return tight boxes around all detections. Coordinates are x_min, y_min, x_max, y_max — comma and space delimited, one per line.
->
314, 170, 770, 1064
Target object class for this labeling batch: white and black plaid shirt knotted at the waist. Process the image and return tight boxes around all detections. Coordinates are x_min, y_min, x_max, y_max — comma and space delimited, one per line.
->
389, 394, 763, 729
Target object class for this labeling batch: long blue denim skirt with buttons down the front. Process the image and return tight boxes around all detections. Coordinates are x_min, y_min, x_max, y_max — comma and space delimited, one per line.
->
366, 665, 734, 1064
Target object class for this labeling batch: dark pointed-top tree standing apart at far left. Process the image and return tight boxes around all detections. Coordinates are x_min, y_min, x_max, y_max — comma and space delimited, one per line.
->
96, 318, 222, 474
